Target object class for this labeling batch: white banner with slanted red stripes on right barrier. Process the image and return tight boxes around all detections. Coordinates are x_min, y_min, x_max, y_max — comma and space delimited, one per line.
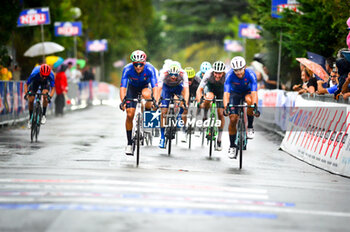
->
281, 96, 350, 176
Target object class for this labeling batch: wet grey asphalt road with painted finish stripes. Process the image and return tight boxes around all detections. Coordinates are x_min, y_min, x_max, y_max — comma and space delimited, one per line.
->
0, 106, 350, 232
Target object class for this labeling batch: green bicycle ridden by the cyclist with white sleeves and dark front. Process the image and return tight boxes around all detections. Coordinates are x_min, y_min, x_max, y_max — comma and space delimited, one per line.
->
200, 96, 222, 159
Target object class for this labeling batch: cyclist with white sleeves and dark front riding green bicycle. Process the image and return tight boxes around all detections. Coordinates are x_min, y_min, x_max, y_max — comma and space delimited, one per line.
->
196, 61, 226, 151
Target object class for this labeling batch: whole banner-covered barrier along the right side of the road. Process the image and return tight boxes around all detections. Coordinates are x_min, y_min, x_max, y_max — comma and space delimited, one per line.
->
257, 90, 350, 177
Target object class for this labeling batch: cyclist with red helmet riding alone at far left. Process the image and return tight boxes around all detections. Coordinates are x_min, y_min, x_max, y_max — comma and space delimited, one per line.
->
24, 64, 55, 128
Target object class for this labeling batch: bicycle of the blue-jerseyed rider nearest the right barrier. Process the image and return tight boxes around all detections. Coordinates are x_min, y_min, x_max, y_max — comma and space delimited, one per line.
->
227, 100, 260, 169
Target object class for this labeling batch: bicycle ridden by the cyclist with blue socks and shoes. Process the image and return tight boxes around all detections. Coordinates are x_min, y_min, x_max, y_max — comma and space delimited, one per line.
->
160, 96, 187, 156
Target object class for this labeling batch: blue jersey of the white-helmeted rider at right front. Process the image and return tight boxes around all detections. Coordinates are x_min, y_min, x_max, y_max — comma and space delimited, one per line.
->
224, 68, 258, 93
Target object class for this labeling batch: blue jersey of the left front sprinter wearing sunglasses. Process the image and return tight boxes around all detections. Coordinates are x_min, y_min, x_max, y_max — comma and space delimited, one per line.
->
120, 63, 158, 88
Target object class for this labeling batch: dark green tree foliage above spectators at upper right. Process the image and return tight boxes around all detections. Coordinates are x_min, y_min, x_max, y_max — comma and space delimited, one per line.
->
249, 0, 350, 85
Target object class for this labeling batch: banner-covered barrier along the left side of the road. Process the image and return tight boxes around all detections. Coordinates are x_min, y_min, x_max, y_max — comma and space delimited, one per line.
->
0, 81, 117, 126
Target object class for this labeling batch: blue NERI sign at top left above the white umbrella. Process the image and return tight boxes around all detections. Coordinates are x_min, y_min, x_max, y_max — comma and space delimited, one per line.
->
17, 7, 50, 27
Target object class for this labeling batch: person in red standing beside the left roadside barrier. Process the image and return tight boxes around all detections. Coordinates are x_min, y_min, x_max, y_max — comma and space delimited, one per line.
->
55, 64, 68, 116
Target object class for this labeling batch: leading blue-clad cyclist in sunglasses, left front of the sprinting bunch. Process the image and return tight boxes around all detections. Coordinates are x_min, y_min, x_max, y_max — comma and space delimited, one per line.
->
120, 50, 158, 155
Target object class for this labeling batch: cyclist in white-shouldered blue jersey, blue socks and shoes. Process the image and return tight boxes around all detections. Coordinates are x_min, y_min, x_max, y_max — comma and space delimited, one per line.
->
158, 62, 189, 148
